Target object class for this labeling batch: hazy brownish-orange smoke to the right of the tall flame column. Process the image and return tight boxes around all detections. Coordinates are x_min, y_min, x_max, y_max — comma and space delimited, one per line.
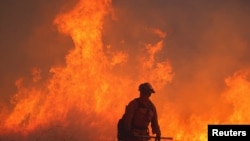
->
104, 0, 249, 111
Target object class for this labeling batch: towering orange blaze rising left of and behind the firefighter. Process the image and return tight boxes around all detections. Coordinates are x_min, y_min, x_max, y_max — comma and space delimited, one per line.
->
1, 0, 172, 140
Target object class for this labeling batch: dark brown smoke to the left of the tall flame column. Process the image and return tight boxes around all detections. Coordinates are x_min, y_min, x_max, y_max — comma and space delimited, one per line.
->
0, 0, 76, 104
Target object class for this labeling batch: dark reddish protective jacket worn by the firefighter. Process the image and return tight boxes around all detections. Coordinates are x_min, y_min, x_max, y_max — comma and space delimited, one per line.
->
124, 98, 160, 141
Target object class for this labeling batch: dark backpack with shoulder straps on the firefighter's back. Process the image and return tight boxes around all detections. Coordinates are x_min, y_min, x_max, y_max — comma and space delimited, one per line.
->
117, 98, 154, 141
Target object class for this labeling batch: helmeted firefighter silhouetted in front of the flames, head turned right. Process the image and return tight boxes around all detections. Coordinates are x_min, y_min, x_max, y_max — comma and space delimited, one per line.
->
124, 82, 161, 141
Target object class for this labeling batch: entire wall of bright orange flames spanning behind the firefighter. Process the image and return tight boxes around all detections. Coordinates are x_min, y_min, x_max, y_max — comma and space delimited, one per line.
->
0, 0, 250, 141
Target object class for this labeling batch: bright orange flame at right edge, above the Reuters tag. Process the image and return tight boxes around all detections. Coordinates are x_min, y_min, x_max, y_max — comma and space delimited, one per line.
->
223, 69, 250, 124
